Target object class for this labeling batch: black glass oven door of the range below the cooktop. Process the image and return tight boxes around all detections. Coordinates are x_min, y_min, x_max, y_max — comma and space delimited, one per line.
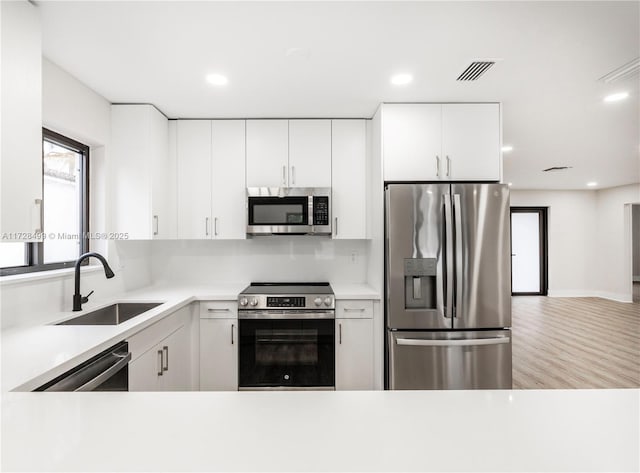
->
238, 318, 335, 390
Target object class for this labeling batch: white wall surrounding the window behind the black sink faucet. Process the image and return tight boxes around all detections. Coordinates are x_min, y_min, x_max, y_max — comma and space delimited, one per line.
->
0, 59, 151, 329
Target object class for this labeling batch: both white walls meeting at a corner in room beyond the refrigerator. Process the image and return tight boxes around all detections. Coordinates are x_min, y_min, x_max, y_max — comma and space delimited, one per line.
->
511, 184, 640, 302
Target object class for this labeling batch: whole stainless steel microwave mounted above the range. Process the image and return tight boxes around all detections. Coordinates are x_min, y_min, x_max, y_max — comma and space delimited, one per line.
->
247, 187, 331, 235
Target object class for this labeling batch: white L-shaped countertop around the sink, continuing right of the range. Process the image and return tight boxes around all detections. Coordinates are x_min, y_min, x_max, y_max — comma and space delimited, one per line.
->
2, 282, 379, 391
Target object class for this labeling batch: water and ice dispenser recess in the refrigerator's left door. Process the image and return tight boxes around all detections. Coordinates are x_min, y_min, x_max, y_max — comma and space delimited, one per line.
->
404, 258, 436, 309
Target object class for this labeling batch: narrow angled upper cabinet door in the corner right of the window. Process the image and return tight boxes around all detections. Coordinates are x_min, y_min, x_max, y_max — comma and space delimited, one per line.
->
147, 105, 176, 240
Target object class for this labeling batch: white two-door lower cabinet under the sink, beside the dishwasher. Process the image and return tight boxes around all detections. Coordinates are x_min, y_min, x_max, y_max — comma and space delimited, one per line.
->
128, 308, 192, 391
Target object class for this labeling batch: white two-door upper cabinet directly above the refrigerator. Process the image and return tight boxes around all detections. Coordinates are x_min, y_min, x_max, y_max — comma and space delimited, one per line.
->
382, 103, 501, 181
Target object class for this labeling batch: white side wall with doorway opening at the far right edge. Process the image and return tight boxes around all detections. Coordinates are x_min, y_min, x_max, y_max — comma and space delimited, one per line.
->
595, 184, 640, 302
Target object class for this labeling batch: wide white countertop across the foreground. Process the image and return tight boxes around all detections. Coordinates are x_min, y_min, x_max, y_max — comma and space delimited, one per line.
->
2, 389, 640, 471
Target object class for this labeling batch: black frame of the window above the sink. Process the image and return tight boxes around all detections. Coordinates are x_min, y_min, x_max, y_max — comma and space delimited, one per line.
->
0, 127, 90, 276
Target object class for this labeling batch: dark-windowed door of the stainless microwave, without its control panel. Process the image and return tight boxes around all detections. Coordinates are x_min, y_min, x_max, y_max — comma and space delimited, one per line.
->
247, 196, 313, 235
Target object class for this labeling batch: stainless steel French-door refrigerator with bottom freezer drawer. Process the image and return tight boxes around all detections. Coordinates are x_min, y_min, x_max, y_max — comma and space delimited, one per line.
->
385, 183, 511, 389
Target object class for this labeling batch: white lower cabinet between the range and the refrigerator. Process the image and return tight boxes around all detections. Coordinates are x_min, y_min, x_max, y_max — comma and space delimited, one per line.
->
336, 300, 374, 391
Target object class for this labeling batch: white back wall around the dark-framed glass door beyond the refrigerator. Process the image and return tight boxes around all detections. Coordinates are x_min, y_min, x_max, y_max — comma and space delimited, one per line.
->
511, 190, 598, 296
